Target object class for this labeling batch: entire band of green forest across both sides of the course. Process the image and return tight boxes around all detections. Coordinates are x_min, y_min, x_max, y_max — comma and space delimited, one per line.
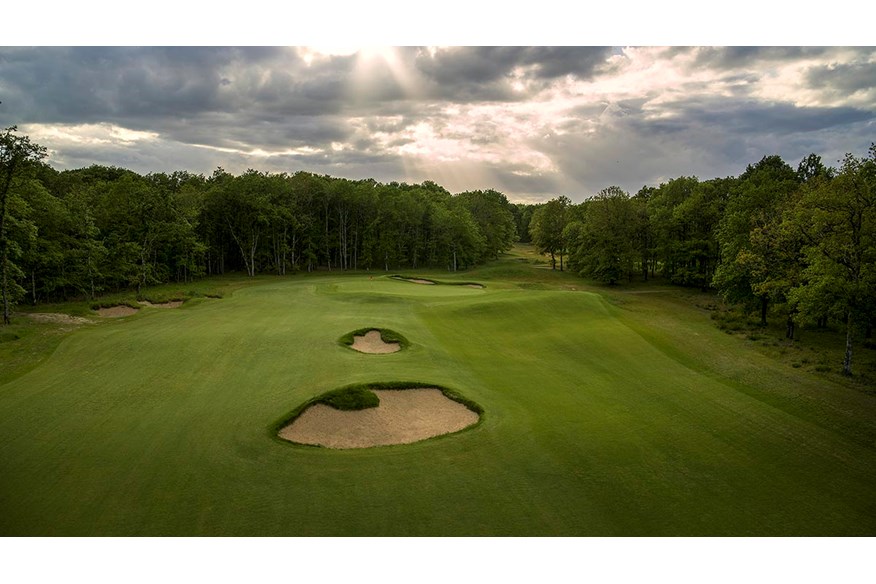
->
0, 128, 876, 372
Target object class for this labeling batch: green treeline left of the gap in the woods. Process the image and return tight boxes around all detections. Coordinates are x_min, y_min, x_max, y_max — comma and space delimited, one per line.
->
0, 128, 516, 315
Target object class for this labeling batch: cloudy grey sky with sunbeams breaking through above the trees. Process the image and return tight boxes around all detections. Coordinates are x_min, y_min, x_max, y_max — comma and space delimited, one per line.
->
0, 13, 876, 202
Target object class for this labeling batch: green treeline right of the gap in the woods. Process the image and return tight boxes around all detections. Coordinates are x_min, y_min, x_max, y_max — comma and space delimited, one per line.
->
516, 145, 876, 373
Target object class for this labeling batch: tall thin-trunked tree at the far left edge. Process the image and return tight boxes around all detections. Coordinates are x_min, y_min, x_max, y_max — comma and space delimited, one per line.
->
0, 126, 46, 325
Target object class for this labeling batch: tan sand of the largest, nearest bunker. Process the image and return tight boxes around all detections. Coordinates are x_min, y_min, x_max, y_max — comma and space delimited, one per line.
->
280, 388, 478, 448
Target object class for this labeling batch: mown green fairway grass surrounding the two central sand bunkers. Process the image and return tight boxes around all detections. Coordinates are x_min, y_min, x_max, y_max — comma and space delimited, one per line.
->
0, 251, 876, 536
